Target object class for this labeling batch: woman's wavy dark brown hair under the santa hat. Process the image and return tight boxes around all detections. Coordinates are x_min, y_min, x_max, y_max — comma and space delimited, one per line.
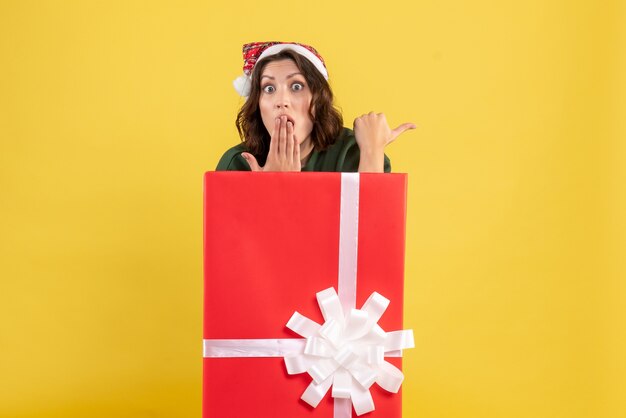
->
235, 49, 343, 164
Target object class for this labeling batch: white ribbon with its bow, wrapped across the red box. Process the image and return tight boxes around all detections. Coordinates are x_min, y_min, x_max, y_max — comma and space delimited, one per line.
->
203, 173, 415, 418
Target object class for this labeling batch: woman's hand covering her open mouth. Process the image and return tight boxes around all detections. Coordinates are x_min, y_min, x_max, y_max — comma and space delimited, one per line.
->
241, 116, 302, 171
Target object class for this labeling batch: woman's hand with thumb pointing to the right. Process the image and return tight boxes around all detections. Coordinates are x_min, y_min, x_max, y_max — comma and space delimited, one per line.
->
354, 112, 415, 173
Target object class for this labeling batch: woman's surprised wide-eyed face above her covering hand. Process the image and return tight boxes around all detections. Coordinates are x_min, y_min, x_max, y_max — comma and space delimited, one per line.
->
259, 59, 313, 148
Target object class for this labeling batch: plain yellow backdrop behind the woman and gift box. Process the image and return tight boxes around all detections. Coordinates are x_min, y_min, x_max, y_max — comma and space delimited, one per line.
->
0, 0, 626, 418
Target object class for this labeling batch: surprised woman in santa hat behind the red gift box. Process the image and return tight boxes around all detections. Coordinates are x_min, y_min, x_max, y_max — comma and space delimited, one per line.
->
217, 42, 415, 173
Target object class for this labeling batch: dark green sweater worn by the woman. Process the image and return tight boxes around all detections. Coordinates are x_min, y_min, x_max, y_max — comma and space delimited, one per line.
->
215, 128, 391, 173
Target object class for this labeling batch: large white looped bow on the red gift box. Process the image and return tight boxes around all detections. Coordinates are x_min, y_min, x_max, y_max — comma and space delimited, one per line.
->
284, 287, 415, 415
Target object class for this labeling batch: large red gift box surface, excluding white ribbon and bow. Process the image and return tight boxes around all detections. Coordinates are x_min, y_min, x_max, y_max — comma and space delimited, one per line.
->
203, 172, 406, 418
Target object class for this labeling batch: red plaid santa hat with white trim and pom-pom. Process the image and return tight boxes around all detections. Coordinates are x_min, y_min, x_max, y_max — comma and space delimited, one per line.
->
233, 42, 328, 97
